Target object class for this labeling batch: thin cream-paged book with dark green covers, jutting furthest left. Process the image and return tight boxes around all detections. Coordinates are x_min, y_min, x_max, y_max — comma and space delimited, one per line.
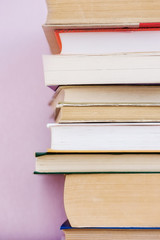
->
35, 152, 160, 174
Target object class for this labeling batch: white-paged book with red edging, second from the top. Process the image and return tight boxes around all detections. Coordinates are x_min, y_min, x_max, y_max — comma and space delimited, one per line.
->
56, 28, 160, 55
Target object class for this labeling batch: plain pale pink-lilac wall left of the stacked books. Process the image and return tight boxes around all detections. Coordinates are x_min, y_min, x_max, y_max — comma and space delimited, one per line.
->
0, 0, 66, 240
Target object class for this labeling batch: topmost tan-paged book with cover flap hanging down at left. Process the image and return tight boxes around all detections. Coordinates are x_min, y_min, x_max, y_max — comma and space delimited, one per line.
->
43, 0, 160, 53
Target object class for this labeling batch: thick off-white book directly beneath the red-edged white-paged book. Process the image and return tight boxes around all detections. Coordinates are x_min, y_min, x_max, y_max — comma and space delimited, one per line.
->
43, 52, 160, 85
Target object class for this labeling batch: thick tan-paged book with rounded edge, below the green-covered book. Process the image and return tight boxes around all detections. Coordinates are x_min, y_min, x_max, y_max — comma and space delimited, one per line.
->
64, 173, 160, 228
